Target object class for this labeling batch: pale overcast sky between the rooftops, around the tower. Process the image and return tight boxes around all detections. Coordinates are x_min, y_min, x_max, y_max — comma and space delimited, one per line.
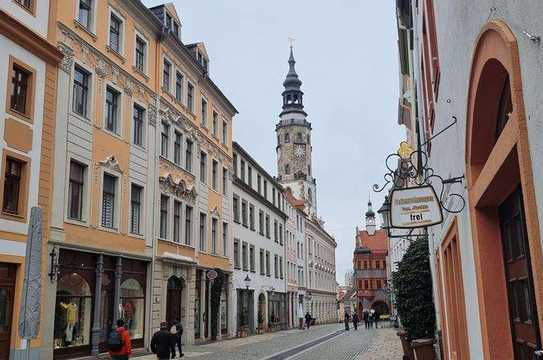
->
144, 0, 405, 284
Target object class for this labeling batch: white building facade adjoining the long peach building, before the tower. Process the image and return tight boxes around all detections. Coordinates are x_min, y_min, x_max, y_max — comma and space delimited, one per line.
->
233, 143, 288, 336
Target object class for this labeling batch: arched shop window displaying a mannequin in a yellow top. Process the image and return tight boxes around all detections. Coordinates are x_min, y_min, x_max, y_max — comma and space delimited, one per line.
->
54, 272, 92, 349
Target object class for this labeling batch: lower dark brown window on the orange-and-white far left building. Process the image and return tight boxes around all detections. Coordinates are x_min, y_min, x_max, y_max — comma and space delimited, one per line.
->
2, 157, 24, 215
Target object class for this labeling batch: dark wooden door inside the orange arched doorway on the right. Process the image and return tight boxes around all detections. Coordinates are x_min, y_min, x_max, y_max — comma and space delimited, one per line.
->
498, 188, 541, 360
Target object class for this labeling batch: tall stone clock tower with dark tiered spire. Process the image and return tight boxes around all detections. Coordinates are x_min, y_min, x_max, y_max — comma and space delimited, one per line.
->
275, 46, 317, 215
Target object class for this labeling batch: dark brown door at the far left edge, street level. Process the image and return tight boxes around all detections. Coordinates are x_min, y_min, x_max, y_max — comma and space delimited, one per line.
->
0, 263, 17, 360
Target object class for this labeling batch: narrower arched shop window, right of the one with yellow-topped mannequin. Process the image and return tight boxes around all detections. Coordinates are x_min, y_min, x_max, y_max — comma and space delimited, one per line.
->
119, 279, 145, 339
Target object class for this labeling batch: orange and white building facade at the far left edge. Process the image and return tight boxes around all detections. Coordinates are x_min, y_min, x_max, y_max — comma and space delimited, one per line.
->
0, 1, 62, 360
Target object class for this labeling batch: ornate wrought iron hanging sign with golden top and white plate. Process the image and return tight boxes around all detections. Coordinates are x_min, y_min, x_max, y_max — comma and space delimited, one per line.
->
373, 135, 466, 229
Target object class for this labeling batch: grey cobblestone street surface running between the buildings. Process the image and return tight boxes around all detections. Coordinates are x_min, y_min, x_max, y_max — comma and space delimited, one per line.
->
138, 324, 401, 360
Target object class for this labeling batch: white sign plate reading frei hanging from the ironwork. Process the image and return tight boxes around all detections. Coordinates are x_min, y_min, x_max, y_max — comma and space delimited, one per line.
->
390, 185, 443, 229
